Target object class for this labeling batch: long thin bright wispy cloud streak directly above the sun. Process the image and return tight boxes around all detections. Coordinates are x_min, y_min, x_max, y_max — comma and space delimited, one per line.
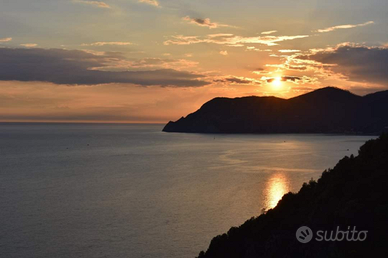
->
164, 34, 309, 47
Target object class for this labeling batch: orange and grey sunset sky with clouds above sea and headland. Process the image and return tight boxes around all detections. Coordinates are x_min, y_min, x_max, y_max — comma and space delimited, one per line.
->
0, 0, 388, 123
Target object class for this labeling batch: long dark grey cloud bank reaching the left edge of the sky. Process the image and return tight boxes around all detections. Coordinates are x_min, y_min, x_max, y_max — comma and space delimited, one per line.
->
0, 48, 209, 87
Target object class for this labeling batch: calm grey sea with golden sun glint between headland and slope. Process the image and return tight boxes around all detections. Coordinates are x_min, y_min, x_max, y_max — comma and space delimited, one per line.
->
0, 124, 371, 258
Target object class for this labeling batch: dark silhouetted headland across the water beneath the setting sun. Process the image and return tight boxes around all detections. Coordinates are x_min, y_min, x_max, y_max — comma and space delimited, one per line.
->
163, 87, 388, 134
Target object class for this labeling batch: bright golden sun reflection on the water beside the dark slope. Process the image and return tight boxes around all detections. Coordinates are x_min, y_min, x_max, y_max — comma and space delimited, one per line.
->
264, 173, 290, 210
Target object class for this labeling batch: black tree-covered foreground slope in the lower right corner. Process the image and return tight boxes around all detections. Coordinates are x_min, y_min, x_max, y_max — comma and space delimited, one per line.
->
199, 134, 388, 258
